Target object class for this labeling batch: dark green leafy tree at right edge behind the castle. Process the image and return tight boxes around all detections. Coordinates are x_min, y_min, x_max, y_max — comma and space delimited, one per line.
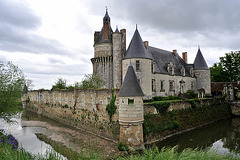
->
210, 51, 240, 82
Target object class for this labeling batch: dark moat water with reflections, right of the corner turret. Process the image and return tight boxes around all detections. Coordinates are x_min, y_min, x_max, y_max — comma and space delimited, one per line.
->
149, 118, 240, 156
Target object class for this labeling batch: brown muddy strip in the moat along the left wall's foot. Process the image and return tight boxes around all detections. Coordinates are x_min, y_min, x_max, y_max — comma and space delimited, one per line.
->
21, 111, 120, 158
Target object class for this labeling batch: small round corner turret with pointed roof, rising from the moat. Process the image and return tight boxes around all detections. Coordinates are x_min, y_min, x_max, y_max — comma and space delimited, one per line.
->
119, 63, 144, 149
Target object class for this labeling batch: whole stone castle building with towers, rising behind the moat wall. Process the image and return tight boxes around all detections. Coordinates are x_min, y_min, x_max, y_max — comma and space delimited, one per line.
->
91, 11, 211, 98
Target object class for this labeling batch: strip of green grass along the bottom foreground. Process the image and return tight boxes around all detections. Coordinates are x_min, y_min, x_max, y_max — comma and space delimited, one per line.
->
0, 132, 240, 160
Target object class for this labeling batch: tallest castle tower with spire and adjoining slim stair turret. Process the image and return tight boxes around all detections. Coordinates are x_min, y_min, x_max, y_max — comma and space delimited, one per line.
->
91, 9, 126, 89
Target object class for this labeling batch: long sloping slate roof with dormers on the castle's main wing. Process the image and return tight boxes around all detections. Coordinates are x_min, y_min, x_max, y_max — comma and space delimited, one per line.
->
147, 46, 192, 76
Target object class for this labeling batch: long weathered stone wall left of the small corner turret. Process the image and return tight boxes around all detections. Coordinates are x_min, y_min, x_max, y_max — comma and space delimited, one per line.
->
26, 89, 119, 141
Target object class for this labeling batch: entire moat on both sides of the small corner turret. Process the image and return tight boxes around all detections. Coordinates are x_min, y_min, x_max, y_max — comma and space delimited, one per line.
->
0, 112, 240, 157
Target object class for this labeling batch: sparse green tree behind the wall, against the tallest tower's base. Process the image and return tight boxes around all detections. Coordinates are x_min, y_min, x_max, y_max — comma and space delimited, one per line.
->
80, 74, 105, 89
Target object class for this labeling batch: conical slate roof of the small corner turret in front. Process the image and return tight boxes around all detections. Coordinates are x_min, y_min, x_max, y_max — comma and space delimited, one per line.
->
118, 63, 144, 97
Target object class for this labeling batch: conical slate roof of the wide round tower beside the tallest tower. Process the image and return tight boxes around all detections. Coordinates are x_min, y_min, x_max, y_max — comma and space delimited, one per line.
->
124, 28, 151, 59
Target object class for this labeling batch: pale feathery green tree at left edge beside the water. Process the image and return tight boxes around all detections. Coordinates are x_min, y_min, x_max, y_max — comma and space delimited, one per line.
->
0, 62, 25, 115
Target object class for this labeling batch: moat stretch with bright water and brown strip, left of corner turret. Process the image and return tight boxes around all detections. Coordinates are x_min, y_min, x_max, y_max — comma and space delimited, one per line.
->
0, 111, 118, 157
